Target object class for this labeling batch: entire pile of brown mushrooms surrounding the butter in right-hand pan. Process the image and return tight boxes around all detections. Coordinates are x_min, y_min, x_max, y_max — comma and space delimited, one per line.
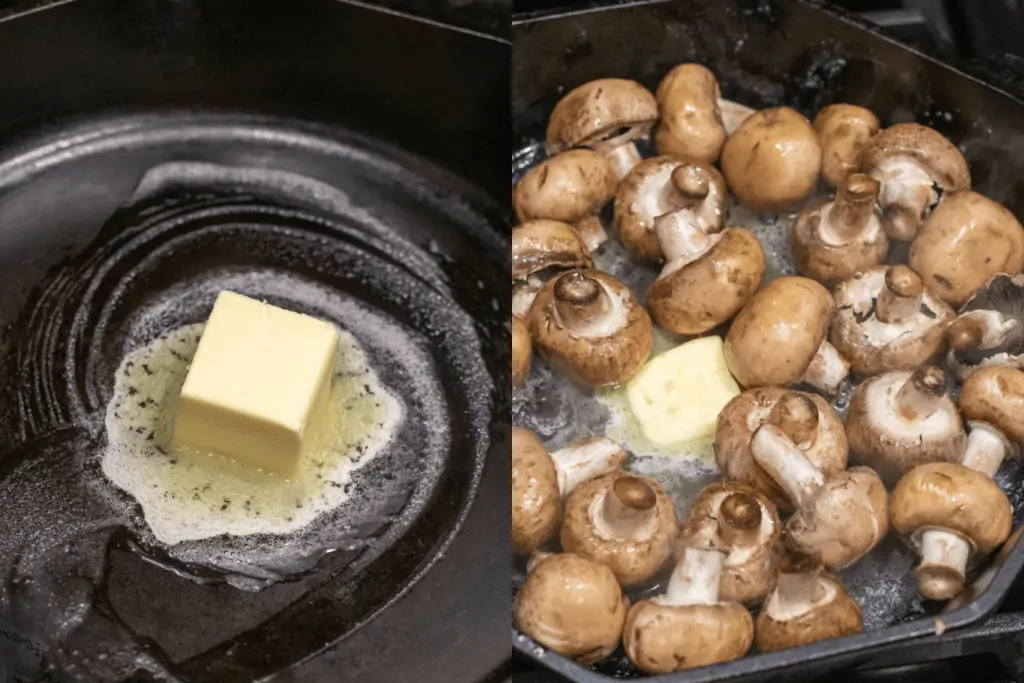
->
511, 63, 1024, 674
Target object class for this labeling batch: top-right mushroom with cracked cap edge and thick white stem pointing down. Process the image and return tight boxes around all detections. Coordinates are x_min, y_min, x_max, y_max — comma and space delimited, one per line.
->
860, 123, 971, 242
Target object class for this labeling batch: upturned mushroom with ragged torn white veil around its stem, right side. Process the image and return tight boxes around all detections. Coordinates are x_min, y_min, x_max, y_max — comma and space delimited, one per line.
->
828, 265, 956, 376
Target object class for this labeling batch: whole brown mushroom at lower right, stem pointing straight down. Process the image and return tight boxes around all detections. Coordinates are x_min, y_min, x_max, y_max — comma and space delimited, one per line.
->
892, 463, 1013, 600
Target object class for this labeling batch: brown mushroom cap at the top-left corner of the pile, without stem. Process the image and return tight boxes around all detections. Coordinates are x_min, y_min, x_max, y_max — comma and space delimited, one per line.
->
548, 78, 657, 156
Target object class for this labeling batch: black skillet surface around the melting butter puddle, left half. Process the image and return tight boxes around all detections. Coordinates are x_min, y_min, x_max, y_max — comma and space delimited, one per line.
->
0, 0, 510, 683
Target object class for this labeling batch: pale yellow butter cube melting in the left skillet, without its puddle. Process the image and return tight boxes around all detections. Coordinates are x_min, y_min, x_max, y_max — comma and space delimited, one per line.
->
174, 292, 338, 477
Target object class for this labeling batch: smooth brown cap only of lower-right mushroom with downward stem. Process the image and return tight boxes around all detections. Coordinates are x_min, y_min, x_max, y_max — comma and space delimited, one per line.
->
889, 463, 1013, 554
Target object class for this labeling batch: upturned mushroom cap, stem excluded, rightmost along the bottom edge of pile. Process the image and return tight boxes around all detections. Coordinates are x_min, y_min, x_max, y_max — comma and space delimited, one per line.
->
757, 575, 863, 652
